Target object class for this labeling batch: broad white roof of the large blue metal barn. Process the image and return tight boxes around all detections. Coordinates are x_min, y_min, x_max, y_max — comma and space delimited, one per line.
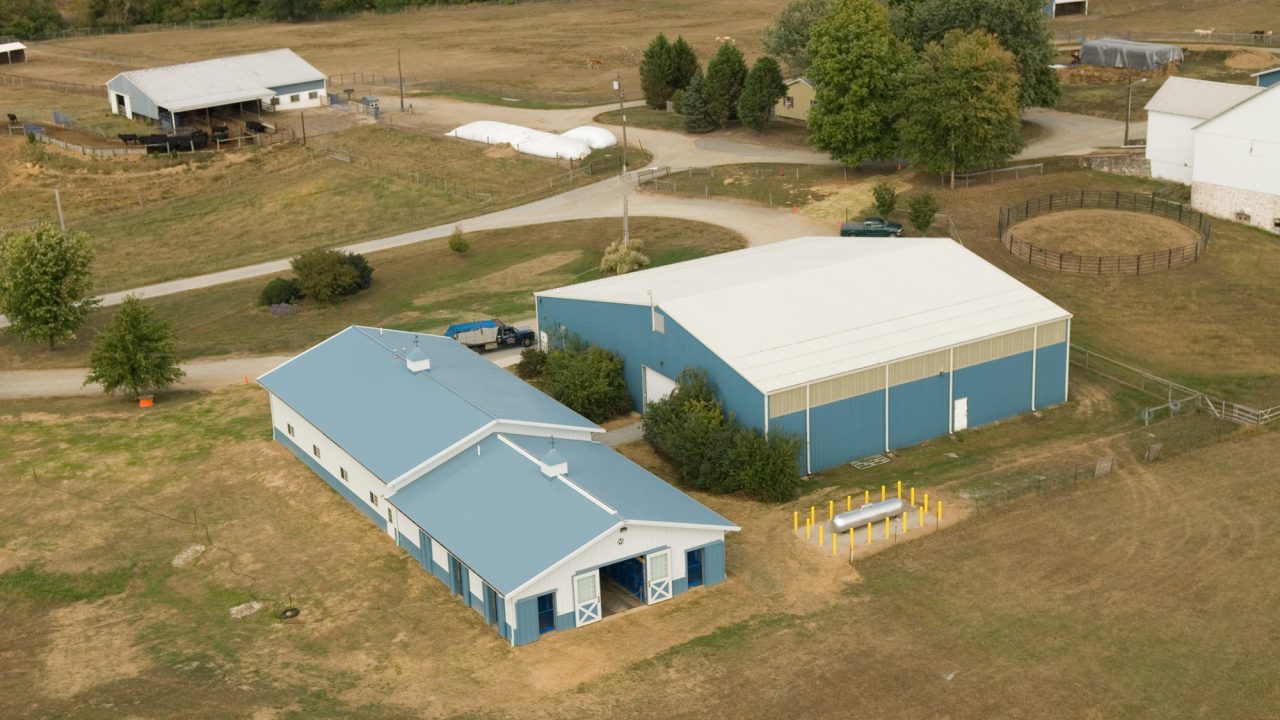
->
538, 237, 1070, 393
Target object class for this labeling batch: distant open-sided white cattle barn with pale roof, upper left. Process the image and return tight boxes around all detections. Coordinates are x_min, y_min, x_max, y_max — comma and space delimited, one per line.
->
106, 49, 328, 128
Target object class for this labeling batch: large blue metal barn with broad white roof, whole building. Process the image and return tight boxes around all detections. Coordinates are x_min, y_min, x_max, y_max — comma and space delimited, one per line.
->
536, 237, 1071, 471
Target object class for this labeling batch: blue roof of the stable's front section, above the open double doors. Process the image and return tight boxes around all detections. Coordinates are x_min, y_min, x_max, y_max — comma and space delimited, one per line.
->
390, 434, 736, 594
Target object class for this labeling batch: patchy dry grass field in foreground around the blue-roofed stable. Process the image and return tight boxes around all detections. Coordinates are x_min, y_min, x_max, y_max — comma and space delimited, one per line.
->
0, 363, 1280, 720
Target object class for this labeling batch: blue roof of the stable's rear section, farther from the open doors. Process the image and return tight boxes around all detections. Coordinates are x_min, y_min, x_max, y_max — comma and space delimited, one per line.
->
259, 327, 599, 483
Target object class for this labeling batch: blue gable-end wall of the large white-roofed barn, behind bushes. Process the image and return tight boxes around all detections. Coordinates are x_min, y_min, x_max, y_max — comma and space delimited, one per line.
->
538, 297, 764, 430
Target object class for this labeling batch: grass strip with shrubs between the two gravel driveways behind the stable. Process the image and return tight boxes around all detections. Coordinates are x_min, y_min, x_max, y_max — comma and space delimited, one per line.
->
0, 218, 742, 369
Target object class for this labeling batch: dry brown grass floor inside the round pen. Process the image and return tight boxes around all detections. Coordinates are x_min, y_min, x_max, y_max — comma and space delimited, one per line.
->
1011, 210, 1199, 256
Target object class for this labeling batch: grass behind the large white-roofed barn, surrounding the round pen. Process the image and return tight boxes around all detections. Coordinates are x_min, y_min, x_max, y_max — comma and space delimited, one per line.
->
645, 163, 1280, 406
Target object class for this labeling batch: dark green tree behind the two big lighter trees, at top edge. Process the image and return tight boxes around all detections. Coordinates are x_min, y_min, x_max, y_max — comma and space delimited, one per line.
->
890, 0, 1061, 108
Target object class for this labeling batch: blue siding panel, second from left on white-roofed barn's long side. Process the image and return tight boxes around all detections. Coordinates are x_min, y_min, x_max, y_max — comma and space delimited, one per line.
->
809, 389, 884, 473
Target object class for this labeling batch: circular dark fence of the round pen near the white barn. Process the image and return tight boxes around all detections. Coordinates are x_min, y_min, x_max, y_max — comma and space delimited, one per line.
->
996, 191, 1211, 275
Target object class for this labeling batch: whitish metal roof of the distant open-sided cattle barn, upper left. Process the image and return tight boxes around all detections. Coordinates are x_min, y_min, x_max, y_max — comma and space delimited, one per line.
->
111, 49, 325, 113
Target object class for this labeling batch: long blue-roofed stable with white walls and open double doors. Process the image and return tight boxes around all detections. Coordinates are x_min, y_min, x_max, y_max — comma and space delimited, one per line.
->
259, 327, 739, 646
